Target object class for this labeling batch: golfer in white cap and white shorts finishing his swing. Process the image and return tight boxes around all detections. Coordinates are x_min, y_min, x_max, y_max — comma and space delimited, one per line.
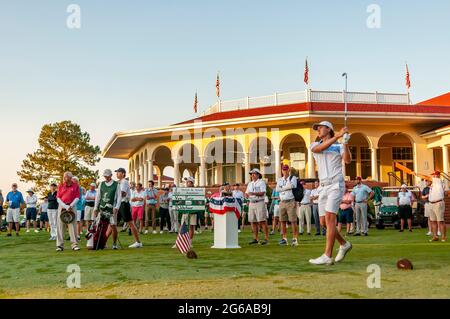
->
309, 121, 352, 265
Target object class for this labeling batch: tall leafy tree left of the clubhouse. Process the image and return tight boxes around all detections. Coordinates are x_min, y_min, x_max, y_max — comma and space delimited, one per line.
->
17, 121, 100, 194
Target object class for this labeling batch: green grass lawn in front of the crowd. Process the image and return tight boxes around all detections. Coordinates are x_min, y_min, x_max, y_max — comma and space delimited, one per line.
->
0, 228, 450, 298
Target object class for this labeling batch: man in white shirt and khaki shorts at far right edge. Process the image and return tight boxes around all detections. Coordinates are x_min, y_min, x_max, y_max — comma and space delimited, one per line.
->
428, 171, 447, 242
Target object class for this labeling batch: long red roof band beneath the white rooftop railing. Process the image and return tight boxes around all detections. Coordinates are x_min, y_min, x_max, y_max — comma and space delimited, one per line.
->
177, 102, 450, 124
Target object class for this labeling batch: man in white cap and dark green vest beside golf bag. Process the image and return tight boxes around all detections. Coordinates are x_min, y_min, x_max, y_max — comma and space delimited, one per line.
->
94, 169, 122, 249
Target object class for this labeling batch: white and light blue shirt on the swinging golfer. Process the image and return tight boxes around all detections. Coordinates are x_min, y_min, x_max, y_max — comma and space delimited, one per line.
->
309, 142, 344, 182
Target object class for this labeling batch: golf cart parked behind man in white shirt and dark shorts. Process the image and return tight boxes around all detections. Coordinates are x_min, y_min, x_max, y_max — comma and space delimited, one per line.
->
375, 186, 428, 229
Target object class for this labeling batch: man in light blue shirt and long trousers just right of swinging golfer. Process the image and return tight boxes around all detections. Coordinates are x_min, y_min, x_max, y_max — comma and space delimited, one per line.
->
352, 176, 373, 236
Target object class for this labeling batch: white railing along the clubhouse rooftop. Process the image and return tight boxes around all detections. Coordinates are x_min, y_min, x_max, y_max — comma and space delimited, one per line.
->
201, 90, 411, 116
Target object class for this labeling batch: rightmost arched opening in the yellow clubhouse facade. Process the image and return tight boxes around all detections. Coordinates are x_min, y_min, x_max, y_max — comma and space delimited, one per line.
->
378, 133, 414, 186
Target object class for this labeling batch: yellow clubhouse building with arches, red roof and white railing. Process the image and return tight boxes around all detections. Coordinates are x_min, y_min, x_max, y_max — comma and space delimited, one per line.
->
103, 89, 450, 186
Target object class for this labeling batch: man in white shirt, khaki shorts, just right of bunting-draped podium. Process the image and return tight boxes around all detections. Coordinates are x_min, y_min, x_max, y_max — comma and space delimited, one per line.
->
245, 168, 269, 245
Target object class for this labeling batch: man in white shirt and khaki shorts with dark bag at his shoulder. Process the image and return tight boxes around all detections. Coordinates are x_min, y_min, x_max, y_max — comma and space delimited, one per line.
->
276, 165, 298, 246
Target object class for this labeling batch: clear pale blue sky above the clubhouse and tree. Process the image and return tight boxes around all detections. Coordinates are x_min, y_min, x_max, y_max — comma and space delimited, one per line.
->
0, 0, 450, 193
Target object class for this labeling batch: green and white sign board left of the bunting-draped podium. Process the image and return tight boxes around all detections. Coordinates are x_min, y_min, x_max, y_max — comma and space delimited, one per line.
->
172, 187, 206, 214
